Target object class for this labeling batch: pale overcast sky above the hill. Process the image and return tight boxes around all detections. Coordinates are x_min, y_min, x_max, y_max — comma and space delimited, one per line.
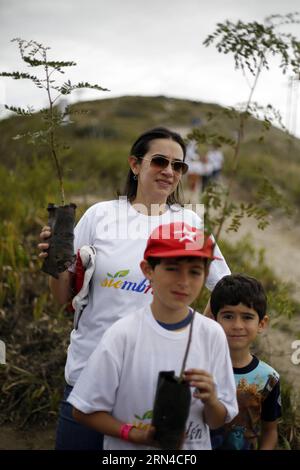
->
0, 0, 300, 136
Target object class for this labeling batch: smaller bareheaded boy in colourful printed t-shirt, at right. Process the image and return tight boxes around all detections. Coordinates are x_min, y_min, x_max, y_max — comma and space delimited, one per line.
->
210, 274, 281, 450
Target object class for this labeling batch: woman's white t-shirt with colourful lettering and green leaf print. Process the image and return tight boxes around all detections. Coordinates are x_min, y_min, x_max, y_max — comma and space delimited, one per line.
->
65, 198, 230, 386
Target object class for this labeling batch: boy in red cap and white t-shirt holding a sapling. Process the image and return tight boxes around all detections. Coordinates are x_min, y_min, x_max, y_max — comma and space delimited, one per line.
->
68, 222, 238, 450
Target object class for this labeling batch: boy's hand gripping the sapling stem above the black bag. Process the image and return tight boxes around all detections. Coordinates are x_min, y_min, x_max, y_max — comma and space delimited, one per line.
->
184, 369, 218, 405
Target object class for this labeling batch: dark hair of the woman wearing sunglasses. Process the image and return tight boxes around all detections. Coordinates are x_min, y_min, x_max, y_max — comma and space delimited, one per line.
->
124, 127, 186, 205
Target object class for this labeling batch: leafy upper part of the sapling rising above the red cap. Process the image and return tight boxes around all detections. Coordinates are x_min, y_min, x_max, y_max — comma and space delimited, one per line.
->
189, 13, 300, 240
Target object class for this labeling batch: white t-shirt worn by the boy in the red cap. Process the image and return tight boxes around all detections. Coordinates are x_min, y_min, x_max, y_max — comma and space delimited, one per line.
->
68, 306, 238, 450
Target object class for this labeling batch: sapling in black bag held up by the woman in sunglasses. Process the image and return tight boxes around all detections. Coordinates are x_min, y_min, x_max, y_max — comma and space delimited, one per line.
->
0, 38, 108, 278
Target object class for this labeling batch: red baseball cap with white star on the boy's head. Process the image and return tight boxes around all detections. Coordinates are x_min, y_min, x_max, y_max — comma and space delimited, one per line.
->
144, 222, 221, 259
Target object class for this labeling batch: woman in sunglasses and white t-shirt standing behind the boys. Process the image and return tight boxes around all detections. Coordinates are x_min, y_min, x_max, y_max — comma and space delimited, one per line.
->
39, 128, 230, 450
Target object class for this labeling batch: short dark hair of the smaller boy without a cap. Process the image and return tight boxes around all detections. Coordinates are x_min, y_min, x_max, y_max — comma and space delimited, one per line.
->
210, 274, 267, 320
